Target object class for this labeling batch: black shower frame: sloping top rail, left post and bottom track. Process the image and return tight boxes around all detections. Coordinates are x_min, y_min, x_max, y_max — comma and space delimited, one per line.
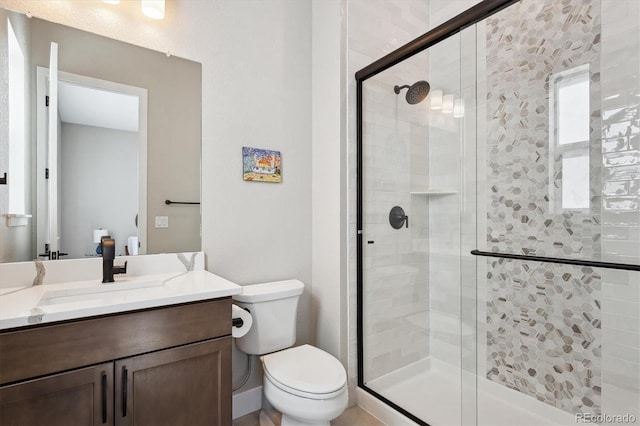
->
355, 0, 519, 426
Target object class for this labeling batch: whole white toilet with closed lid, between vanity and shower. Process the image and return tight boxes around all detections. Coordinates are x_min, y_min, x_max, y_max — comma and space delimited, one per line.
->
233, 280, 348, 426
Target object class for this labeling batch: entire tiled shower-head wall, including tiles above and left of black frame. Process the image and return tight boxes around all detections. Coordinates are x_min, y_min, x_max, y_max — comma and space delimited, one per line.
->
346, 0, 429, 383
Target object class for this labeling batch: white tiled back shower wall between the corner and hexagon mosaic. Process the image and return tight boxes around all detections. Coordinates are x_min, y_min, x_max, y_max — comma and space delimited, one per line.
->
422, 0, 477, 366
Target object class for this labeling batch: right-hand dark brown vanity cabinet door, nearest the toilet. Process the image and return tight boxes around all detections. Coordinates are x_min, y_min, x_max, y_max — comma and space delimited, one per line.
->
115, 337, 231, 426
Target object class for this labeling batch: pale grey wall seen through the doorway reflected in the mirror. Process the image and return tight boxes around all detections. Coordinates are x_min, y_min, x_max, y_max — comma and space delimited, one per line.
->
59, 123, 138, 259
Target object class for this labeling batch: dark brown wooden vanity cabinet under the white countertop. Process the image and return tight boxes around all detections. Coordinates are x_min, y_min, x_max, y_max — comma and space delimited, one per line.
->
0, 298, 231, 426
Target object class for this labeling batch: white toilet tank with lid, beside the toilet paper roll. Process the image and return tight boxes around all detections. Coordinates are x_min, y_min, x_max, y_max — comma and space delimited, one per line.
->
233, 280, 304, 355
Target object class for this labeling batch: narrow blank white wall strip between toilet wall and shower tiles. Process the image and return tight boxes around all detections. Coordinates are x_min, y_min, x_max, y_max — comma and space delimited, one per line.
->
311, 0, 347, 365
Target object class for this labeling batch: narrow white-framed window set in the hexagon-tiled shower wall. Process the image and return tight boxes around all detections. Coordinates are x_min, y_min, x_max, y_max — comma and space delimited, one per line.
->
549, 65, 591, 212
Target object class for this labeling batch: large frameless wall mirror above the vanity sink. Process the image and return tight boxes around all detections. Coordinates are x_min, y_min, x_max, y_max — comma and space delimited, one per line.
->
0, 9, 202, 262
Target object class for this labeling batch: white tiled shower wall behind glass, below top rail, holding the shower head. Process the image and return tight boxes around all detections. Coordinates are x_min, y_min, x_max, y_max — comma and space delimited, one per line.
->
363, 23, 429, 381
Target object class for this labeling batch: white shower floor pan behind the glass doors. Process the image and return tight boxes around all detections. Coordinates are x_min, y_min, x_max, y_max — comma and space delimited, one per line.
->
367, 358, 576, 426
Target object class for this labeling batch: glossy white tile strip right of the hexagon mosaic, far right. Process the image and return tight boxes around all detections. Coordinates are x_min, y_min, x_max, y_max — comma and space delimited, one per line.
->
601, 0, 640, 424
